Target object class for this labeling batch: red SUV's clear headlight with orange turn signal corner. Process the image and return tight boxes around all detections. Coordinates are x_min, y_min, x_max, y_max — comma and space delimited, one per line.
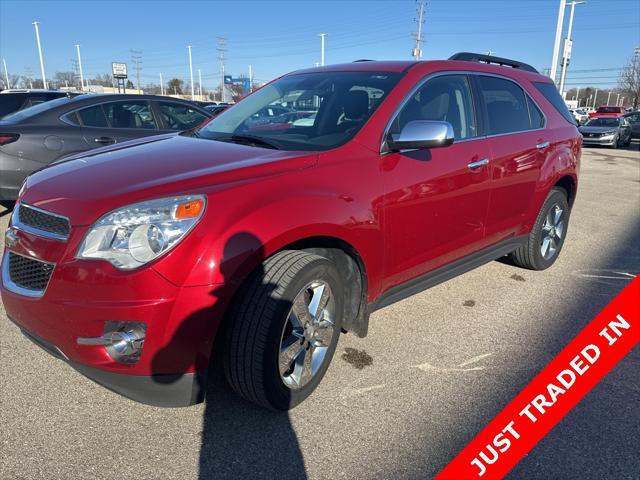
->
76, 195, 206, 270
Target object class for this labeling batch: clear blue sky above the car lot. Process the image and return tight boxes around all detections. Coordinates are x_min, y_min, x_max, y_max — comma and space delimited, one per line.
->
0, 0, 640, 89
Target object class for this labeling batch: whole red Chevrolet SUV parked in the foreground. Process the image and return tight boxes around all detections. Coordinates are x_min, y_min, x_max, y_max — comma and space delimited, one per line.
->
1, 53, 581, 409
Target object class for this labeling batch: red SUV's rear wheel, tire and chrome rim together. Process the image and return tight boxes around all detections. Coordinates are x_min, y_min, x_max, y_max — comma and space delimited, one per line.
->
510, 187, 570, 270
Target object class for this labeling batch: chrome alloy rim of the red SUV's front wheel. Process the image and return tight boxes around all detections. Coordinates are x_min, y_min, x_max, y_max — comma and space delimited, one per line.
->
278, 280, 336, 390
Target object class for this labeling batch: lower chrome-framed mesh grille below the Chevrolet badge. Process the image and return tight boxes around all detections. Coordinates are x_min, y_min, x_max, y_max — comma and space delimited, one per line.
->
2, 251, 55, 297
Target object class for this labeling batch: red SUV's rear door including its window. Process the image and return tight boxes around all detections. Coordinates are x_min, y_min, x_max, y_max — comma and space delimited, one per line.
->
474, 74, 550, 244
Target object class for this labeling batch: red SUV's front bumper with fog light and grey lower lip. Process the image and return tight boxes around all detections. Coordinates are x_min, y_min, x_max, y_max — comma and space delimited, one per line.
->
0, 256, 225, 407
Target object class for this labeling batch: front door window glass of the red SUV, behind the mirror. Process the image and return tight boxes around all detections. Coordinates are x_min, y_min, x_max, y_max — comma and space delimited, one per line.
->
389, 75, 477, 140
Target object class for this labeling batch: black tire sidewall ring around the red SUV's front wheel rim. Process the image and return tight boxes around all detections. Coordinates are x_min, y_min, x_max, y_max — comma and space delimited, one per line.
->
262, 258, 344, 410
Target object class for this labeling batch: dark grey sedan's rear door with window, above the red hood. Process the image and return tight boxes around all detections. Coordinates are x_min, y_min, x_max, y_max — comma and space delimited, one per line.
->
78, 100, 160, 148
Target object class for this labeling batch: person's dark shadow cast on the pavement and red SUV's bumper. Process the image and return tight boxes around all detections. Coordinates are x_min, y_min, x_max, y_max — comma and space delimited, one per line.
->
153, 232, 307, 480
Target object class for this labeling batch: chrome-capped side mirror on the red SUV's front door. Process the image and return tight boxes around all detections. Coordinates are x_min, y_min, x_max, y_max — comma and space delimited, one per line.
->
387, 120, 454, 151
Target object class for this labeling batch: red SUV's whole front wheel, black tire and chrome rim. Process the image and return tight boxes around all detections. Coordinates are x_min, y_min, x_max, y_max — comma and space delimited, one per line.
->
224, 250, 344, 410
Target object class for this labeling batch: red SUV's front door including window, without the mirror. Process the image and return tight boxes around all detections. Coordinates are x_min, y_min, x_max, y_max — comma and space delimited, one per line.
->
380, 74, 490, 290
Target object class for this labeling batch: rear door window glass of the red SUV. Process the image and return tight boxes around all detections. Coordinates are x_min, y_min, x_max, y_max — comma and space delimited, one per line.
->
478, 76, 531, 135
